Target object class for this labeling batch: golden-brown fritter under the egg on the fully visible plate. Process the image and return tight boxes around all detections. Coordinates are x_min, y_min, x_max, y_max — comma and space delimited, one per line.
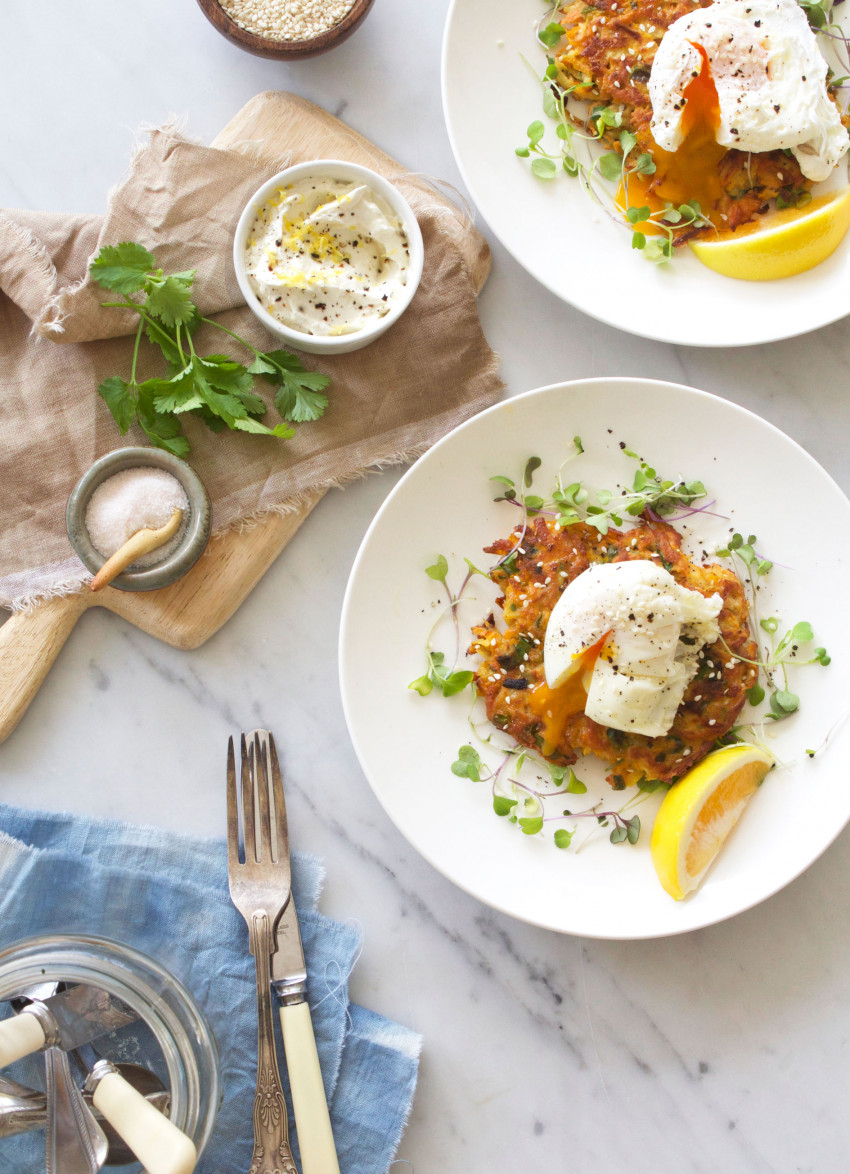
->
470, 517, 757, 790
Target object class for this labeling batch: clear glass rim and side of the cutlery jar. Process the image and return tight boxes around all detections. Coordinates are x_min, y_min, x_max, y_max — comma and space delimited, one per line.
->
0, 935, 222, 1154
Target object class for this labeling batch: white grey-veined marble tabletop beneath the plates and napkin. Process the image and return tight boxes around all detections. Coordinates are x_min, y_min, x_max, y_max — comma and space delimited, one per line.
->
0, 0, 850, 1174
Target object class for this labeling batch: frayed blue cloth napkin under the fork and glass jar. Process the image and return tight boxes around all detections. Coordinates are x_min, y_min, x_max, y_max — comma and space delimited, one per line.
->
0, 804, 420, 1174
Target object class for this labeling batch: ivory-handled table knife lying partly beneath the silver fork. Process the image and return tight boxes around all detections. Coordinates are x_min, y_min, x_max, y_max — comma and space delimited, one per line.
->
248, 730, 339, 1174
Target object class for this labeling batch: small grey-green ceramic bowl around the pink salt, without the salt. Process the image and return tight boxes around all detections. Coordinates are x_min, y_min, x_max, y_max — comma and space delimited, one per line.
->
65, 447, 213, 591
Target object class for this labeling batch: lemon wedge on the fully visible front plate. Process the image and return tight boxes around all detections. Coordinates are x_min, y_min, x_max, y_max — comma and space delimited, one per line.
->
649, 743, 774, 900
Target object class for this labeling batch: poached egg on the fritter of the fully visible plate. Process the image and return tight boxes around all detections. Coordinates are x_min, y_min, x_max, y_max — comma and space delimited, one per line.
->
544, 559, 723, 737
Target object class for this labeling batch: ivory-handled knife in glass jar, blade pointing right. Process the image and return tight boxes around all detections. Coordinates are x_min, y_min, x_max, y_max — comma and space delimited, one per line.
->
0, 984, 133, 1068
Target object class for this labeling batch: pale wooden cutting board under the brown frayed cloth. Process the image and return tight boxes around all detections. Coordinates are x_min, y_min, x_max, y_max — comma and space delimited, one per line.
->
0, 98, 488, 742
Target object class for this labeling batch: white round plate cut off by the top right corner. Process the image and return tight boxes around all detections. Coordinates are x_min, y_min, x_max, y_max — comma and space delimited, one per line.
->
443, 0, 850, 346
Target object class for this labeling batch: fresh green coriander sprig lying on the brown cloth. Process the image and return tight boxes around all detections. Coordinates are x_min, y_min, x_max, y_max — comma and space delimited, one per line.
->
89, 242, 330, 457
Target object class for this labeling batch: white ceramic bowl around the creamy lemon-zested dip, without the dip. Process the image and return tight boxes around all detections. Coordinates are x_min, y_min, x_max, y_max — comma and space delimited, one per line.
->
234, 158, 425, 355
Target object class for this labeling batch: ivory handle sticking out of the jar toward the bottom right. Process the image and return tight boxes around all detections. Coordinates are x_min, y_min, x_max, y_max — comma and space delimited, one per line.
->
92, 1072, 197, 1174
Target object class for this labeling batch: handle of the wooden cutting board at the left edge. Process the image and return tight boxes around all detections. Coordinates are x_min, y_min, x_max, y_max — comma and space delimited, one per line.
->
0, 593, 88, 742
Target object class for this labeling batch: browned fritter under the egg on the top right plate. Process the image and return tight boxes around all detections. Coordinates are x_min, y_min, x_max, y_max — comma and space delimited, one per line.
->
547, 0, 826, 235
